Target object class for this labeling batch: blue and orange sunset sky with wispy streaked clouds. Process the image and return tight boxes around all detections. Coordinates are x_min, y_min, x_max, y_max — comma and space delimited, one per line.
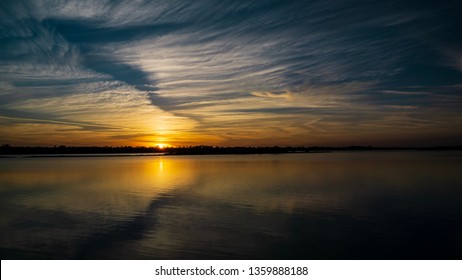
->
0, 0, 462, 146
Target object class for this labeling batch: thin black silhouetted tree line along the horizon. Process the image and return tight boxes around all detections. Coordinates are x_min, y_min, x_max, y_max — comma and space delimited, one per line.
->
0, 144, 462, 155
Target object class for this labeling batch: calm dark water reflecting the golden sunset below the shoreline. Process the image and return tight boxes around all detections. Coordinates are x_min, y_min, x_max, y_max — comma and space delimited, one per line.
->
0, 152, 462, 259
